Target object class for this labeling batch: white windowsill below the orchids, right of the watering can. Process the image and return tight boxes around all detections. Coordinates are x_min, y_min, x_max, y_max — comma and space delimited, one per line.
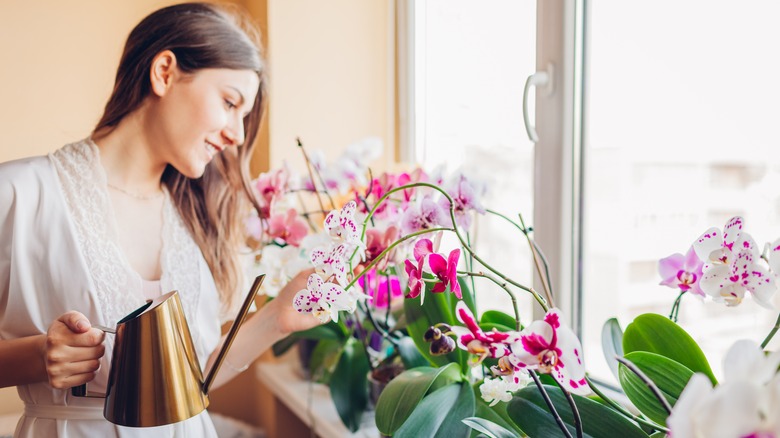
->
255, 360, 379, 438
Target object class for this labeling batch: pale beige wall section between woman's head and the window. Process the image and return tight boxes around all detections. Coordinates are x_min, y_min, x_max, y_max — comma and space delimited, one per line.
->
268, 0, 395, 168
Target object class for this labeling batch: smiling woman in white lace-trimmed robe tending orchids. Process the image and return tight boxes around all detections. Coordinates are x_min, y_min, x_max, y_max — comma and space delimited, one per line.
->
0, 3, 313, 437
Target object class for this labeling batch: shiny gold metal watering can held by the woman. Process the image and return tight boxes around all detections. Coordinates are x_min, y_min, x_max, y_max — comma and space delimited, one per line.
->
71, 275, 265, 427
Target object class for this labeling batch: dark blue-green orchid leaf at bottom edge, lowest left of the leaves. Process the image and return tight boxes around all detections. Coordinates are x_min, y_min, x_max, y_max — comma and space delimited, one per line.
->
393, 383, 474, 438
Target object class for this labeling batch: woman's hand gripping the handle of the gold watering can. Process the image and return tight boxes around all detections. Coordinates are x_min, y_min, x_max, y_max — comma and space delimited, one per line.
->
43, 311, 105, 389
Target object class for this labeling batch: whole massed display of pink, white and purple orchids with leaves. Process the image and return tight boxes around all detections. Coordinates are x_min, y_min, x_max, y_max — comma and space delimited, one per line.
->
247, 136, 780, 438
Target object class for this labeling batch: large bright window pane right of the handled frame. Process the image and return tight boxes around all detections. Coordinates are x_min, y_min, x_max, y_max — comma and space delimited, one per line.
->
582, 0, 780, 377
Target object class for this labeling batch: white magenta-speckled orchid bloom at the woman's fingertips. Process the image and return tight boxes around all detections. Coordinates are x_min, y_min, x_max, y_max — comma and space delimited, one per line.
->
293, 274, 352, 322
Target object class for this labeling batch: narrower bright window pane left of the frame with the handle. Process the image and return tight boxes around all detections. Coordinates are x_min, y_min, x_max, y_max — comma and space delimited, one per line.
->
414, 0, 536, 319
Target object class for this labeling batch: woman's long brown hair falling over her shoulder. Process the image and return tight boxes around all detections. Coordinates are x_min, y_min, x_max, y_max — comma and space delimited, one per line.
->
95, 3, 266, 312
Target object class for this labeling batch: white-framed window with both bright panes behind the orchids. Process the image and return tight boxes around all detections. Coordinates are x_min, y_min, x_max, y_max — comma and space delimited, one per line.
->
402, 0, 780, 386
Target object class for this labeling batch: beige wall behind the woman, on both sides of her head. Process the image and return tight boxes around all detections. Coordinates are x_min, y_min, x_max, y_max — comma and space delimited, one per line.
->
0, 0, 394, 422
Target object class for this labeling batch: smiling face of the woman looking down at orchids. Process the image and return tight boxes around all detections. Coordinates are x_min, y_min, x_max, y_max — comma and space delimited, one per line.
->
150, 69, 260, 178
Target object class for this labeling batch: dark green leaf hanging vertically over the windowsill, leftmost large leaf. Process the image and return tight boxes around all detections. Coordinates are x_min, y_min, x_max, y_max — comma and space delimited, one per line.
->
330, 338, 369, 432
